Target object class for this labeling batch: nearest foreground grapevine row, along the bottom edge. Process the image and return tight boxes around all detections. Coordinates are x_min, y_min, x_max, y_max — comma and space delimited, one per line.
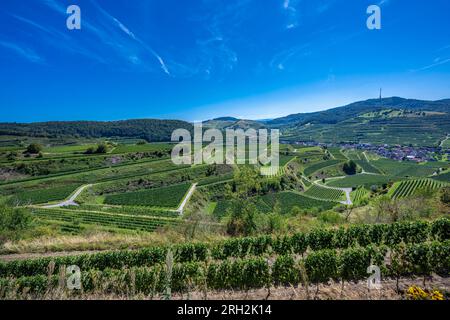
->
0, 241, 450, 295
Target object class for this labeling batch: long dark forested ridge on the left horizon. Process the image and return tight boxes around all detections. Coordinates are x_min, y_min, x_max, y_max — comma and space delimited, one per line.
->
0, 119, 192, 142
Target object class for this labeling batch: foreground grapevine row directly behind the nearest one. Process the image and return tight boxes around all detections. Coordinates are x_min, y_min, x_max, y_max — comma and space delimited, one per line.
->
0, 218, 450, 277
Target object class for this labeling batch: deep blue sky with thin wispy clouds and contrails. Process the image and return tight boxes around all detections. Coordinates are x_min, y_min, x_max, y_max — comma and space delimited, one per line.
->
0, 0, 450, 122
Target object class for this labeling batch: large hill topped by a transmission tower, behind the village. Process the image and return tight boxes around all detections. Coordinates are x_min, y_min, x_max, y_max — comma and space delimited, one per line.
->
264, 97, 450, 146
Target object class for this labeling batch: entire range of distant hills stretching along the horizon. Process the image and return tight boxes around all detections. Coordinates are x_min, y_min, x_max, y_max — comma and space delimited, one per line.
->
0, 97, 450, 146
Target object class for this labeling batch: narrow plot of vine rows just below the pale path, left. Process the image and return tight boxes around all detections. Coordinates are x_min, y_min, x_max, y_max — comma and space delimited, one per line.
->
33, 208, 182, 232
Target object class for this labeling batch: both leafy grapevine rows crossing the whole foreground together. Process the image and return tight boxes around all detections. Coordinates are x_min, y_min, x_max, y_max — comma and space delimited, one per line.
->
0, 219, 450, 294
